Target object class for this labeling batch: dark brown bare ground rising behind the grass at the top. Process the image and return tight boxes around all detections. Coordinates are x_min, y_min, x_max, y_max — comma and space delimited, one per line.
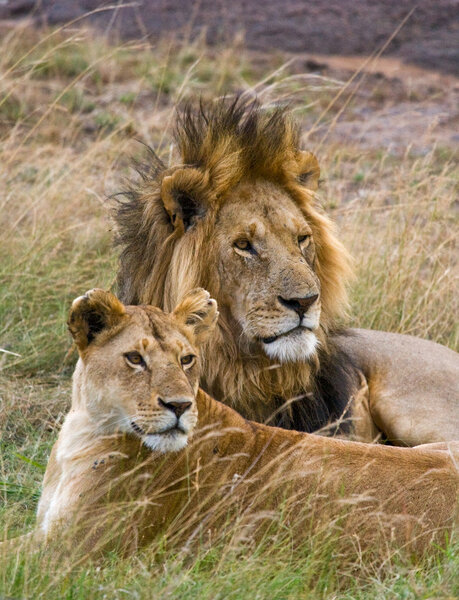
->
0, 0, 459, 74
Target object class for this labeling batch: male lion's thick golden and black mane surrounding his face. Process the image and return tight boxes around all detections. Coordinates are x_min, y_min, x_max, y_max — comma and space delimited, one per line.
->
115, 98, 351, 431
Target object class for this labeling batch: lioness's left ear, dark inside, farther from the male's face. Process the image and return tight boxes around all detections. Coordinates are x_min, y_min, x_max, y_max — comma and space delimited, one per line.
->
68, 288, 125, 352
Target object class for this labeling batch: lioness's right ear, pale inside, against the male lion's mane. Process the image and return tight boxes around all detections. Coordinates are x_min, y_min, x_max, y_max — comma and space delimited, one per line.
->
172, 288, 218, 344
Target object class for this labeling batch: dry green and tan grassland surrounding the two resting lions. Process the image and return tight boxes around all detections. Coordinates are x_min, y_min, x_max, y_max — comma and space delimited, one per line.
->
0, 24, 459, 599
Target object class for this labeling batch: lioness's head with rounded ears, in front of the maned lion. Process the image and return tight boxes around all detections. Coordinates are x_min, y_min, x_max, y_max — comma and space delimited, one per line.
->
69, 289, 218, 452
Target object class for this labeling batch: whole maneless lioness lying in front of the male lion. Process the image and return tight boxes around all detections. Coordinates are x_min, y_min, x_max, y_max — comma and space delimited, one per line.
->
38, 289, 459, 552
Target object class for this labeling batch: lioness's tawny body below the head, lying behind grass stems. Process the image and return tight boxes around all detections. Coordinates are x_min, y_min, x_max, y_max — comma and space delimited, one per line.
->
38, 390, 458, 551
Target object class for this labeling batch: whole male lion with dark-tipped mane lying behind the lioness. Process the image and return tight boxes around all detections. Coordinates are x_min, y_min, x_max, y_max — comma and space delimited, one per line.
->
116, 99, 459, 446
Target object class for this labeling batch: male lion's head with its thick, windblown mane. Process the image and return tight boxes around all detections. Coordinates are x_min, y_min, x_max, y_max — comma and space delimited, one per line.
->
116, 99, 350, 412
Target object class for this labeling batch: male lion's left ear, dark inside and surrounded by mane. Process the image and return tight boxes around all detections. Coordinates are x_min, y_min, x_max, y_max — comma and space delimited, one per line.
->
161, 168, 208, 232
